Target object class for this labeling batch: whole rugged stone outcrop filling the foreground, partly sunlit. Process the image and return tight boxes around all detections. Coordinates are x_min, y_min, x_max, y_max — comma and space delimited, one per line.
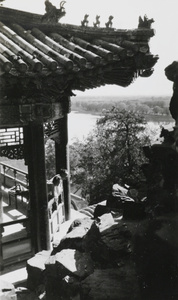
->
27, 206, 178, 300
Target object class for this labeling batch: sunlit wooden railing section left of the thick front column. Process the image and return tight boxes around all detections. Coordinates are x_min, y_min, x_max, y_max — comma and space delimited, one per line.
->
0, 163, 32, 269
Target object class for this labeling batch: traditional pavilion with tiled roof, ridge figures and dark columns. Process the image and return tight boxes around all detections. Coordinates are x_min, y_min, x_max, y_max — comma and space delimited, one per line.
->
0, 1, 158, 264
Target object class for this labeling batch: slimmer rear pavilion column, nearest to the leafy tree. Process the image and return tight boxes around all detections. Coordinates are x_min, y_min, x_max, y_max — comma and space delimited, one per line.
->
55, 114, 71, 220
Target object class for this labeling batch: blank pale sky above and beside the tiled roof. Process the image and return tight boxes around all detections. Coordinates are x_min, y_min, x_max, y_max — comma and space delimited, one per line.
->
3, 0, 178, 97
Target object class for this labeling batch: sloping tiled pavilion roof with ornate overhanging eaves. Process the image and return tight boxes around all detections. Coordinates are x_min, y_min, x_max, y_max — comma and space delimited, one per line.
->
0, 7, 158, 94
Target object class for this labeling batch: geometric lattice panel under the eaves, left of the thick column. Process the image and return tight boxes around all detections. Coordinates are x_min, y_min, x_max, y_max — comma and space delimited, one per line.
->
0, 127, 24, 147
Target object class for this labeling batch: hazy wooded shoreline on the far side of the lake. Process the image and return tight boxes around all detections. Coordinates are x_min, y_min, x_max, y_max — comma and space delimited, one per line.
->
71, 95, 174, 123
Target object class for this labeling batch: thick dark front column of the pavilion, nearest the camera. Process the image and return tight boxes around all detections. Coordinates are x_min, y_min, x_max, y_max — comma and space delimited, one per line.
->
24, 123, 50, 252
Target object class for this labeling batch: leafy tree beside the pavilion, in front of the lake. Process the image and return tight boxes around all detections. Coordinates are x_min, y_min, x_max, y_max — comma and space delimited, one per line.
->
70, 107, 150, 203
